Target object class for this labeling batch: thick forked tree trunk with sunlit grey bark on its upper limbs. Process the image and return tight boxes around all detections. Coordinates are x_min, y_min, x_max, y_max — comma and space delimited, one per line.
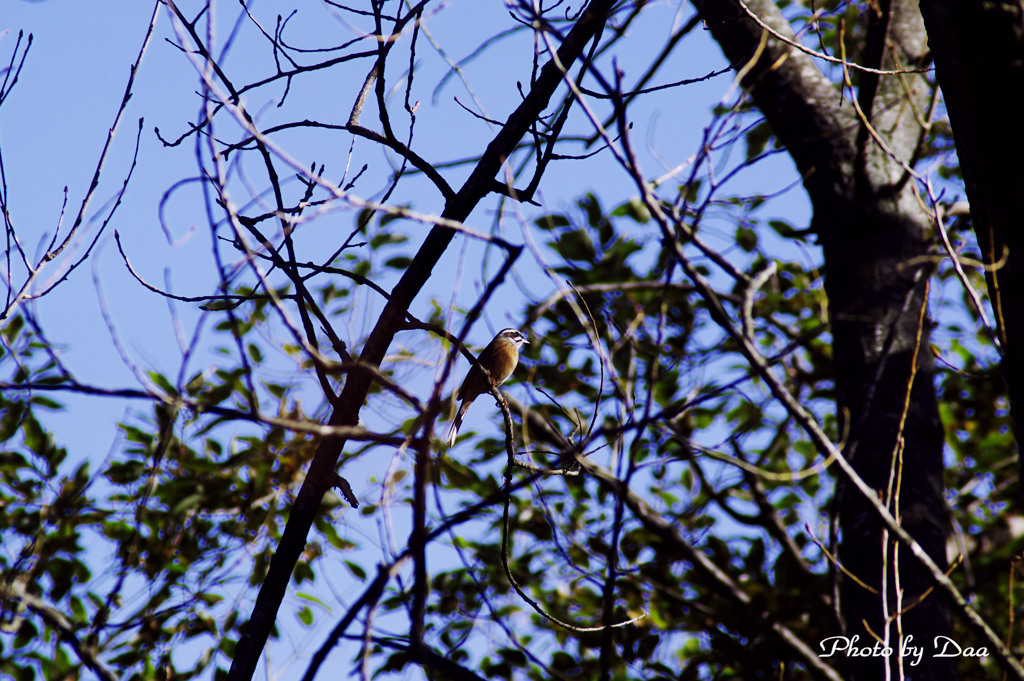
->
694, 0, 955, 680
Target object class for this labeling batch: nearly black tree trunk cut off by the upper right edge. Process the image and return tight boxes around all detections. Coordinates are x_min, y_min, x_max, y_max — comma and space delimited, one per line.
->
921, 0, 1024, 477
